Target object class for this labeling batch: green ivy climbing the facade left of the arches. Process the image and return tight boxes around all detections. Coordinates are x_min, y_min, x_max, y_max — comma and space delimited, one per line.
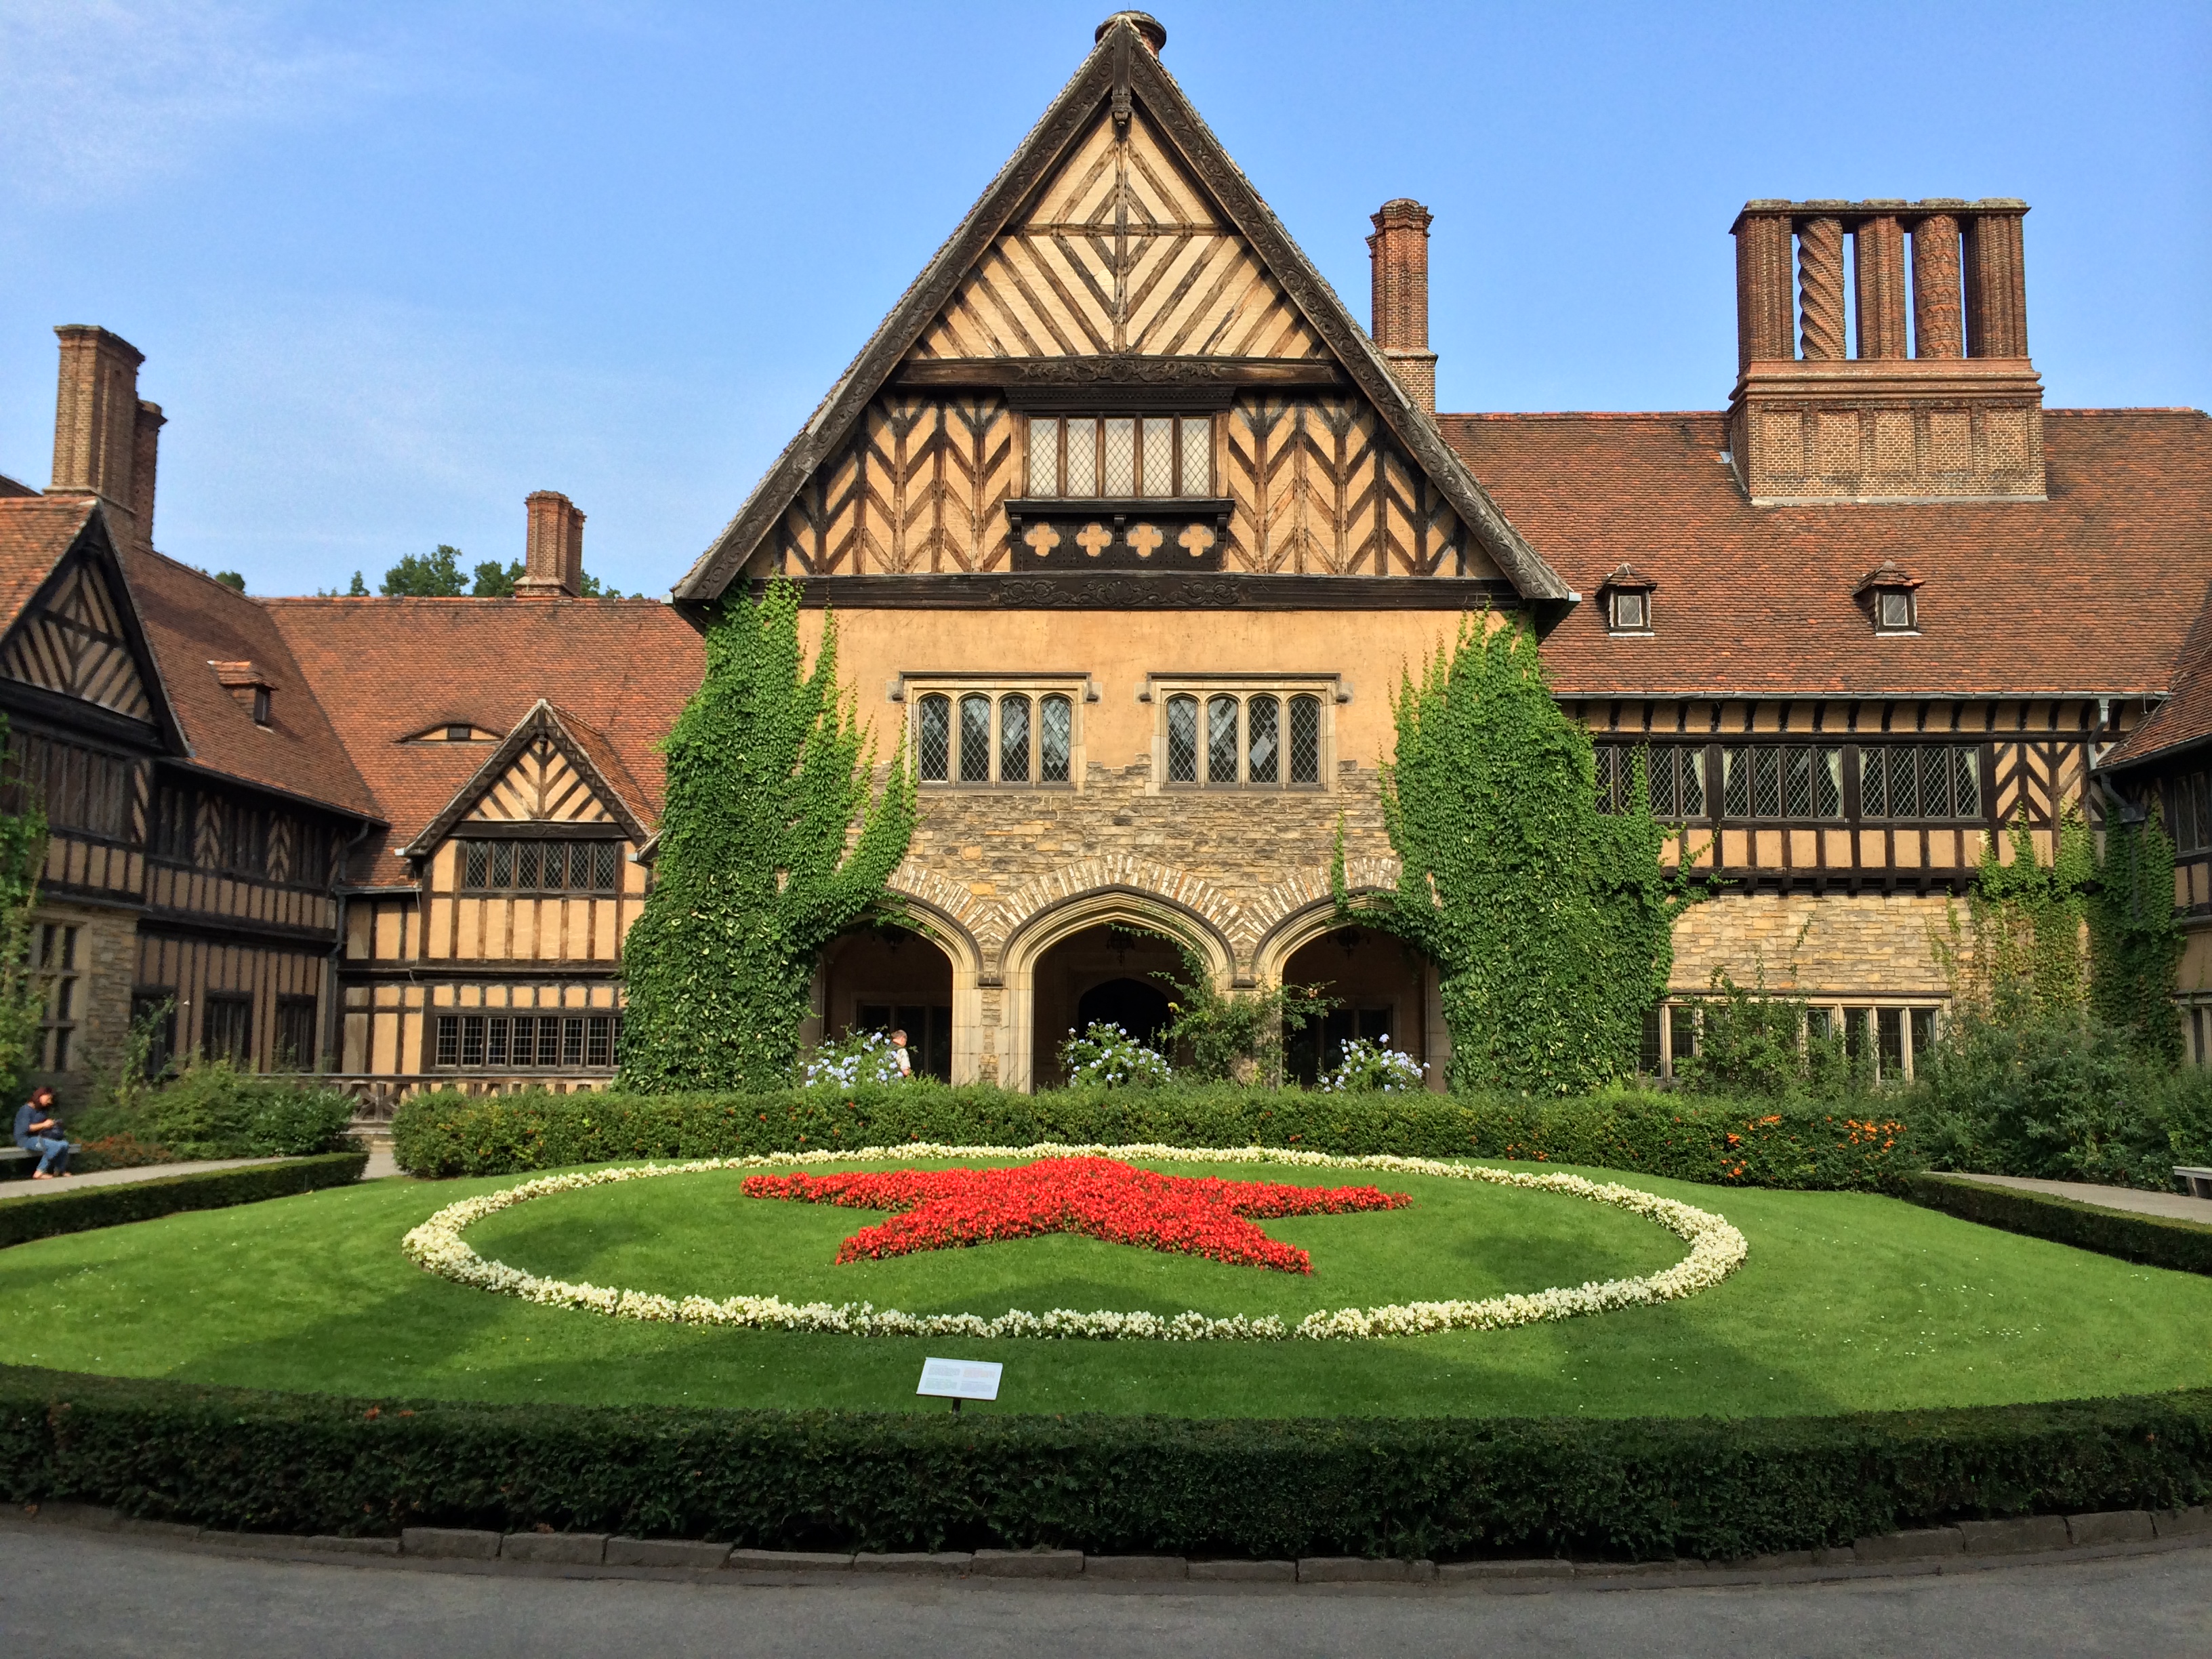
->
619, 581, 916, 1090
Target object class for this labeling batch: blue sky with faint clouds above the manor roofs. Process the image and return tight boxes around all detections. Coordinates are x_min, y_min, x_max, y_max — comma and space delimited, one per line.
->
0, 0, 2212, 593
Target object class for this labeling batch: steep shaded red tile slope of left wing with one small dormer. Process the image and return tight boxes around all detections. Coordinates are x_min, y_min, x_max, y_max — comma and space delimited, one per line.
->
122, 548, 383, 819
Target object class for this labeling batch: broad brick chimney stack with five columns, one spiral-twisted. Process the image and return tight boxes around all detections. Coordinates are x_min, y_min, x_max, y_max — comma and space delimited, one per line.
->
1727, 197, 2044, 506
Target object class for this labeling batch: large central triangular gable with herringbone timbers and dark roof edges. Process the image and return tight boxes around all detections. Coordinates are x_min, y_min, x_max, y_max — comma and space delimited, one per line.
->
675, 14, 1577, 606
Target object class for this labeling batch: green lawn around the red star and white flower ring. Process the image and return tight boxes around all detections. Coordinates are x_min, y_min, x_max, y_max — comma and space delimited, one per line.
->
0, 1166, 2212, 1416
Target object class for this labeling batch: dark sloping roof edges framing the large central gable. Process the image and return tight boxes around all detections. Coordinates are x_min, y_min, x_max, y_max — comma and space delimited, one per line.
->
675, 14, 1575, 602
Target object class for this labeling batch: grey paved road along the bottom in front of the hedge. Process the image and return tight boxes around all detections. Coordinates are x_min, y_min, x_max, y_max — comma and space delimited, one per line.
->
0, 1522, 2212, 1659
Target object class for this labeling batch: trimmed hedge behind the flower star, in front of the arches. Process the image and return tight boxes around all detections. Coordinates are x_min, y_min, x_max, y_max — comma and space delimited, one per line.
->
392, 1084, 1918, 1190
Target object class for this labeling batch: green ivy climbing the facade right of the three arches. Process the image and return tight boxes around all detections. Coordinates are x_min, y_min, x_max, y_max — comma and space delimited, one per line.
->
1332, 617, 1696, 1095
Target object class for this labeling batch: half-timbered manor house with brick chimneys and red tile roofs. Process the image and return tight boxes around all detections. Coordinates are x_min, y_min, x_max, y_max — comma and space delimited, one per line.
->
0, 14, 2212, 1095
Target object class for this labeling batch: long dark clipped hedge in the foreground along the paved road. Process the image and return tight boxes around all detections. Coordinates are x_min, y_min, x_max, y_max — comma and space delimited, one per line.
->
0, 1367, 2212, 1559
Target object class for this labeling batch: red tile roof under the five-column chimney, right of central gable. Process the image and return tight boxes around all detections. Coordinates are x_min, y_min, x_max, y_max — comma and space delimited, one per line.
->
1438, 409, 2212, 697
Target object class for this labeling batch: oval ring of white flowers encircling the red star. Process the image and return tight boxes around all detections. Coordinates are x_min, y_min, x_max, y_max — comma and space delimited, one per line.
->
401, 1141, 1750, 1343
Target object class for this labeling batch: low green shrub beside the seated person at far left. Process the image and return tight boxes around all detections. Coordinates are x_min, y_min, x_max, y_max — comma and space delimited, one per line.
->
68, 1059, 354, 1162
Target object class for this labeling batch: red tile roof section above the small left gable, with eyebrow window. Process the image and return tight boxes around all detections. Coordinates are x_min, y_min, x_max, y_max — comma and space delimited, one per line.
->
265, 600, 705, 882
